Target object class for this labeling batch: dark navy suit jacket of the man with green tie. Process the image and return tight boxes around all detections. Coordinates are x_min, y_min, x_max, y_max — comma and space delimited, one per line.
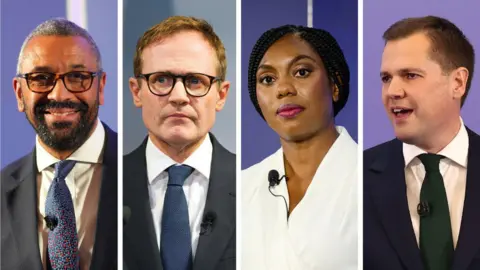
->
363, 128, 480, 270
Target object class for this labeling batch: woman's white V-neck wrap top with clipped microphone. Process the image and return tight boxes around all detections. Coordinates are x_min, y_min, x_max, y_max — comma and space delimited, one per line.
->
242, 127, 358, 270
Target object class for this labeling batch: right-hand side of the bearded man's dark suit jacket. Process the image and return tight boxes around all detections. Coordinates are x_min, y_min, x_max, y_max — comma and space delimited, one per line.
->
90, 125, 118, 270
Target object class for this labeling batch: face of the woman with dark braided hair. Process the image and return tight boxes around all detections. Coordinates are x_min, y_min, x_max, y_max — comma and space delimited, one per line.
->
256, 35, 338, 141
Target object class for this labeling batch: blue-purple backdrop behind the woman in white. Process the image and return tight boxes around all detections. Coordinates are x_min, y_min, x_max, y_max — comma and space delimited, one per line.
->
241, 0, 358, 169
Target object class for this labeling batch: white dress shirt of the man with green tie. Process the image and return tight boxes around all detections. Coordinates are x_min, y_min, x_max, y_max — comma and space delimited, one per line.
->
403, 119, 468, 247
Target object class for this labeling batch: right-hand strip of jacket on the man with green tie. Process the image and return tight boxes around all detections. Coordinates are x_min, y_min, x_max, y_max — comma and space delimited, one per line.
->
452, 128, 480, 270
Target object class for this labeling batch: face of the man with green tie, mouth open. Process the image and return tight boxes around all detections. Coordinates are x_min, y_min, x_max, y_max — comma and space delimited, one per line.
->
380, 33, 468, 145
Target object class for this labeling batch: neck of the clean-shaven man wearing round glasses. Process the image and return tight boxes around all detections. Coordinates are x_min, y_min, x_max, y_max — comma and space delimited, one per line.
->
149, 132, 207, 163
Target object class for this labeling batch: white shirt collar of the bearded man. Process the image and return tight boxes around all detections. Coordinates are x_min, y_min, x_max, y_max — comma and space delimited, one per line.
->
35, 118, 105, 172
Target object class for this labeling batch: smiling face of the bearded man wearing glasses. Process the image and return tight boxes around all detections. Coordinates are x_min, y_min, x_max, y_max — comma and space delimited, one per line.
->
13, 36, 105, 151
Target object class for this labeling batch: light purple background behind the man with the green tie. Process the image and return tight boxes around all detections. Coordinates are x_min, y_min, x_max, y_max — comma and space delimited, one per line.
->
363, 0, 480, 149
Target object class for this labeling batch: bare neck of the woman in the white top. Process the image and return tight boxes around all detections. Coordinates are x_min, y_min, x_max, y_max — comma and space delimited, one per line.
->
281, 124, 339, 182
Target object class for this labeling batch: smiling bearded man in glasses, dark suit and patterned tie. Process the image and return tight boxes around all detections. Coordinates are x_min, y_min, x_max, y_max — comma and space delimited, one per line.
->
0, 19, 117, 269
